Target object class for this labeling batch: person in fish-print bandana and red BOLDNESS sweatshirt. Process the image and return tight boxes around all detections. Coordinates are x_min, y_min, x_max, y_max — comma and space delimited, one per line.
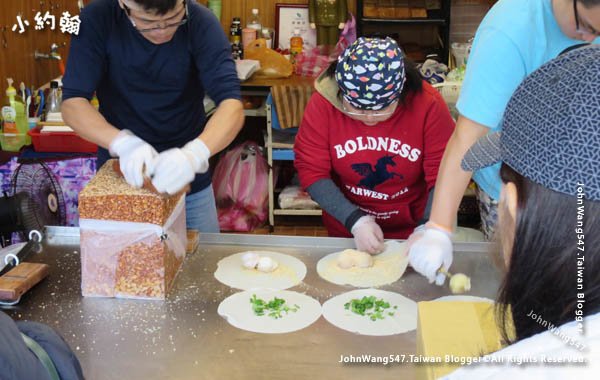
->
294, 37, 454, 254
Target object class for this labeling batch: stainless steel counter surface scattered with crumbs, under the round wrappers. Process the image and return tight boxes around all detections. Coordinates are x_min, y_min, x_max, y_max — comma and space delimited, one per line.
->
5, 228, 500, 380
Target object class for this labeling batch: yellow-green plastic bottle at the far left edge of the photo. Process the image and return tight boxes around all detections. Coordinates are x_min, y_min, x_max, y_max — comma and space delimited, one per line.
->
2, 78, 31, 151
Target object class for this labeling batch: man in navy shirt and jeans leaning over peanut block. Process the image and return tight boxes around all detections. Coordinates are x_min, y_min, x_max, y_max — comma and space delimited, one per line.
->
61, 0, 244, 232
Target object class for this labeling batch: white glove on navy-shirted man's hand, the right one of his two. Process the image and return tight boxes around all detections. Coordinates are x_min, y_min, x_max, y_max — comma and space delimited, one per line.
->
152, 139, 210, 194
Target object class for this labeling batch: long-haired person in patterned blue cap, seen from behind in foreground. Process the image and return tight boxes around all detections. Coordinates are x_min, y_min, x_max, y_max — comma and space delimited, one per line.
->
448, 45, 600, 380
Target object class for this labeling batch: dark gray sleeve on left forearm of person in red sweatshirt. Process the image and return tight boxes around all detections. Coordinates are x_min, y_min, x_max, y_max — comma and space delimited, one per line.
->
306, 179, 366, 231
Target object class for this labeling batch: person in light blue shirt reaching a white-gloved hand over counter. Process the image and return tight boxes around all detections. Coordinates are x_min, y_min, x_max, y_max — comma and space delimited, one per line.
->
410, 0, 600, 285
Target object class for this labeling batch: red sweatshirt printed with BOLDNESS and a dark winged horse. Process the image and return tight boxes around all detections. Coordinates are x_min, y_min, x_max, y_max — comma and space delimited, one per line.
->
294, 82, 454, 239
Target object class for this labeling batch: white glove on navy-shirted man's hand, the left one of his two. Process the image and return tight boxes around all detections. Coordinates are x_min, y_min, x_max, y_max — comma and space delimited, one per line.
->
109, 129, 158, 188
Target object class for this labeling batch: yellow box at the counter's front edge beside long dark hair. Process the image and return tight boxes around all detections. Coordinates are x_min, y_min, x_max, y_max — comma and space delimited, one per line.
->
417, 301, 504, 380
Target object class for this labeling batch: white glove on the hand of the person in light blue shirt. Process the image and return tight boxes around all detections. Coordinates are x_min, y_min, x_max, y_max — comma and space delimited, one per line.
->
408, 224, 452, 285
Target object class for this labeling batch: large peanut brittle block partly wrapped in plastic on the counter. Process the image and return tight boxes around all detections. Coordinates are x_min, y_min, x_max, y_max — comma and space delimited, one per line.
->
79, 161, 187, 299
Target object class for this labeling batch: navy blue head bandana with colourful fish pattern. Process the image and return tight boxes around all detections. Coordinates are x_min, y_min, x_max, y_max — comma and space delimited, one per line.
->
335, 37, 406, 110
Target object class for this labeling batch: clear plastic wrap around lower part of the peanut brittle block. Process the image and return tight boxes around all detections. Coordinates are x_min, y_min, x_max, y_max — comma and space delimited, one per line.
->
79, 196, 187, 299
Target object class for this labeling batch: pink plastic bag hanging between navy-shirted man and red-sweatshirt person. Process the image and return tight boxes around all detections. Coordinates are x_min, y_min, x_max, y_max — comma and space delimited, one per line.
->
213, 141, 269, 231
